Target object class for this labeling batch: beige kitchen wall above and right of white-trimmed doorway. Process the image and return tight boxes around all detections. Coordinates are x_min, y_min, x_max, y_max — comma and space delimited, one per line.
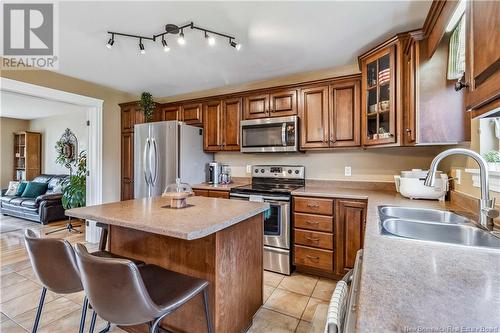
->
0, 70, 137, 202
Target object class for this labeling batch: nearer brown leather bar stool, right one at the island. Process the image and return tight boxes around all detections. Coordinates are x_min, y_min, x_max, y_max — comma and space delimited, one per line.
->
75, 244, 212, 333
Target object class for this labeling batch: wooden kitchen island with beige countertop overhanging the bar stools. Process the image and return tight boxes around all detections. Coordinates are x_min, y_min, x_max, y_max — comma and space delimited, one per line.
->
66, 197, 269, 332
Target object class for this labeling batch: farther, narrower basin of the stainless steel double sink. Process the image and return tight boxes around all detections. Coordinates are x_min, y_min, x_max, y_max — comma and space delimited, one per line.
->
379, 206, 471, 224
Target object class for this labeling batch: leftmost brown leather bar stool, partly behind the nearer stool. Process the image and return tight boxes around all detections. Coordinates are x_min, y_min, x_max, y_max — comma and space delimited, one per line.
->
24, 229, 144, 333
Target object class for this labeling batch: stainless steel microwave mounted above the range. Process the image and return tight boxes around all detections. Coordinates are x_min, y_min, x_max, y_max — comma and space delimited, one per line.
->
240, 116, 299, 153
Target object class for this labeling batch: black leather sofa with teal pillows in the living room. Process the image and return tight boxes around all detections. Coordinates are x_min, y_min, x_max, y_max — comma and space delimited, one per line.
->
0, 174, 68, 224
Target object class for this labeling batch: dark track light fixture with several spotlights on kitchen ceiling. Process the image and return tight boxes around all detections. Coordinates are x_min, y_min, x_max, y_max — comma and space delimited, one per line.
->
106, 22, 241, 54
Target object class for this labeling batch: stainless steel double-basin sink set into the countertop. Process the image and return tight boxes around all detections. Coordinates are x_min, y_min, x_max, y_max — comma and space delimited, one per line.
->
378, 206, 500, 249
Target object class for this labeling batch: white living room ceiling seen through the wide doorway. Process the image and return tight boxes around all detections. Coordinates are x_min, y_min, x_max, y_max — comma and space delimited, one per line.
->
0, 91, 86, 120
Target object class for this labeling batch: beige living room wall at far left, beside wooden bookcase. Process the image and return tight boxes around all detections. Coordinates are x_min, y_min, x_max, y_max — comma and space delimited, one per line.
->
0, 117, 29, 188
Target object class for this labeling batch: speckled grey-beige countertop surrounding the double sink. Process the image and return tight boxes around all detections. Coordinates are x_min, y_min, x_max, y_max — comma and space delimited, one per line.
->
293, 183, 500, 333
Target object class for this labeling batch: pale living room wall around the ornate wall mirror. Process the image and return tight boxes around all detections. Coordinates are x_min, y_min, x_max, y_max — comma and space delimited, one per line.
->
29, 108, 88, 174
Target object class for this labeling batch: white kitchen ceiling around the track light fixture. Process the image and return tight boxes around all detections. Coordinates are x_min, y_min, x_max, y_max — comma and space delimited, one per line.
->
54, 1, 430, 97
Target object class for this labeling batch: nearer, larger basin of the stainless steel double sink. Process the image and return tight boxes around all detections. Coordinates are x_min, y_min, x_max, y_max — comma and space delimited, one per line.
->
382, 219, 500, 249
